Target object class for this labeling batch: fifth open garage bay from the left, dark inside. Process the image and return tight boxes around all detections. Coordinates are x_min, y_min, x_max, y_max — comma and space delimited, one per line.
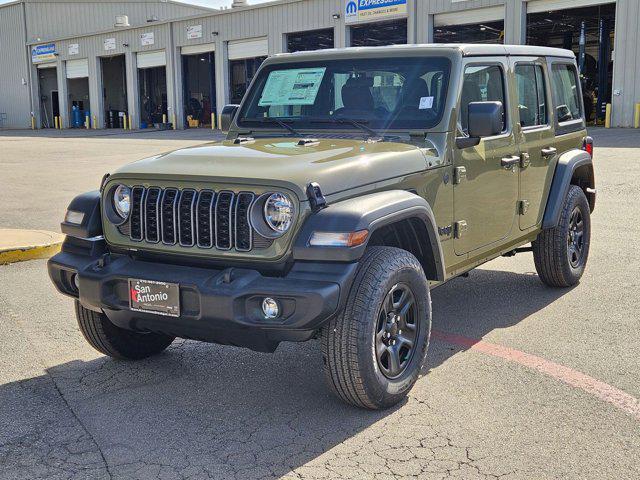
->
182, 43, 216, 128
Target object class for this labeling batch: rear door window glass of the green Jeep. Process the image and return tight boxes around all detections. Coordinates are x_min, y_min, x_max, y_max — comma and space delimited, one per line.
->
515, 64, 547, 127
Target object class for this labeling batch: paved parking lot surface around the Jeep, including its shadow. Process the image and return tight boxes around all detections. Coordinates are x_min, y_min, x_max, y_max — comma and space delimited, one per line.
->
0, 130, 640, 480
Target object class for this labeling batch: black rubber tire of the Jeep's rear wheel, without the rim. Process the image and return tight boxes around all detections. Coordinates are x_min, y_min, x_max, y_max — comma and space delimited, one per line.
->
532, 185, 591, 287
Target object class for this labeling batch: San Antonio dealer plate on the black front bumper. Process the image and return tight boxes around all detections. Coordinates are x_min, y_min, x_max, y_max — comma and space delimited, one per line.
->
129, 278, 180, 317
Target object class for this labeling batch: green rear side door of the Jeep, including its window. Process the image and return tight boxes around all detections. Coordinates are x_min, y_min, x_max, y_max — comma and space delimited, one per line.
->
511, 57, 557, 230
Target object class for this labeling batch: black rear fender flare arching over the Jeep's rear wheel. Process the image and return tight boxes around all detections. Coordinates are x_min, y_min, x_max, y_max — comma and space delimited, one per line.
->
542, 150, 596, 229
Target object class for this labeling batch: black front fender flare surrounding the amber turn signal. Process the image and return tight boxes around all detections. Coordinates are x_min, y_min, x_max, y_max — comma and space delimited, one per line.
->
293, 190, 445, 281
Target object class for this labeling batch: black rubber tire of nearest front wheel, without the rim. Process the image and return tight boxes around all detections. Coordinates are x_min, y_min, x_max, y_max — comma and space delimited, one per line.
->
321, 247, 431, 409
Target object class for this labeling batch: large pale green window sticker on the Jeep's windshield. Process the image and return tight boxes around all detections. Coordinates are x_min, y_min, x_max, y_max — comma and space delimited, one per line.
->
258, 67, 326, 107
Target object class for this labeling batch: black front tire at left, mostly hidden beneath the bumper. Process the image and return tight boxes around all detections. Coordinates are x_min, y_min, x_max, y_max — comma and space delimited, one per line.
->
76, 301, 174, 360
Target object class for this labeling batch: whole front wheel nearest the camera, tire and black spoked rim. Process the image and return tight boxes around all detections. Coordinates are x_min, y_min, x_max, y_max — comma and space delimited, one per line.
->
321, 247, 431, 409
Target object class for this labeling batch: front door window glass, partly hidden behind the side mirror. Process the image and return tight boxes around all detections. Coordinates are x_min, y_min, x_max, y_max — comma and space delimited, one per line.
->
460, 65, 507, 133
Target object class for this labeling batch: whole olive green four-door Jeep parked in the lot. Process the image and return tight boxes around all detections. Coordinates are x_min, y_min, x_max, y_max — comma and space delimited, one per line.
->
48, 45, 596, 409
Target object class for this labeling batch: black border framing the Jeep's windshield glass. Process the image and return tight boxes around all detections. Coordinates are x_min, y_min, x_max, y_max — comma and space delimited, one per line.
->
233, 52, 455, 136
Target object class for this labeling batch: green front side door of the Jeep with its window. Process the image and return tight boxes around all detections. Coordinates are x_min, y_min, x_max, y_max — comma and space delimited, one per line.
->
453, 58, 519, 255
